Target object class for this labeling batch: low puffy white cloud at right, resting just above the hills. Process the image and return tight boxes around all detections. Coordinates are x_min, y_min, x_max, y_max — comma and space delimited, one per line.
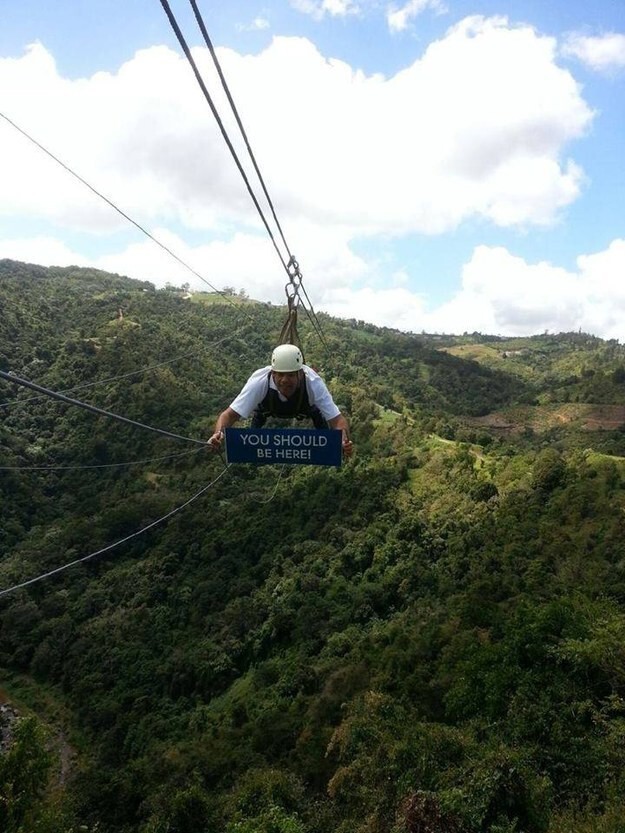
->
319, 239, 625, 342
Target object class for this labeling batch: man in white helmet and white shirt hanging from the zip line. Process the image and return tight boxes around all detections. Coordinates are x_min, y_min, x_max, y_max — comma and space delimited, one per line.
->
208, 344, 353, 457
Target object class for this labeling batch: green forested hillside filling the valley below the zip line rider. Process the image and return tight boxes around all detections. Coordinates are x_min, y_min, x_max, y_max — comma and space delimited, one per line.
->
0, 261, 625, 833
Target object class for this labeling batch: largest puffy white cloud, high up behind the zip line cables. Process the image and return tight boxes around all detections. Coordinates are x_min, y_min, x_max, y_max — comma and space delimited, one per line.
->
0, 18, 592, 244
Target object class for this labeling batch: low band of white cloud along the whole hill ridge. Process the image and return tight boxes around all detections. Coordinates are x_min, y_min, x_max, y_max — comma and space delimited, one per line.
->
7, 227, 625, 342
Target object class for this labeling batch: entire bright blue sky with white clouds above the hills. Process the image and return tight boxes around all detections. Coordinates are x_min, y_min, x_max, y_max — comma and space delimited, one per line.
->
0, 0, 625, 340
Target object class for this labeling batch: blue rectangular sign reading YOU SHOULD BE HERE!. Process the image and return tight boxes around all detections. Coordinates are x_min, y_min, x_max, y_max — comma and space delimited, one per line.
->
225, 428, 343, 466
